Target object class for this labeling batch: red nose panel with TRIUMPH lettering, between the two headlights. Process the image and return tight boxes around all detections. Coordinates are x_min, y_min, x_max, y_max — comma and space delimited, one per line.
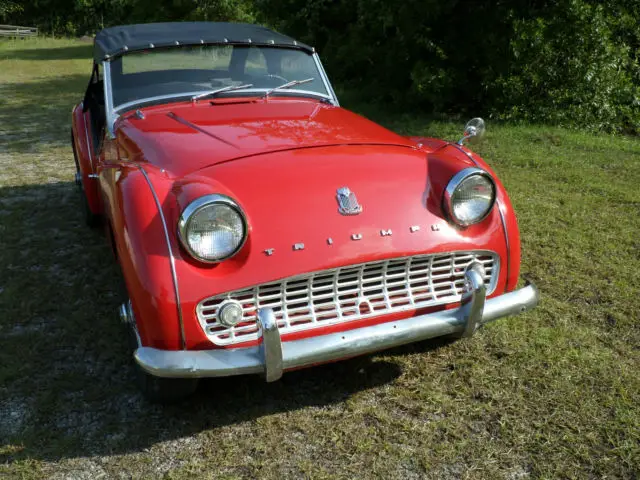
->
168, 145, 502, 295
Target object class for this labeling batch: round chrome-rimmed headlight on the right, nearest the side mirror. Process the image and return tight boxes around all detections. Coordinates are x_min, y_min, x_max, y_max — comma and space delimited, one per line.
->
444, 168, 496, 226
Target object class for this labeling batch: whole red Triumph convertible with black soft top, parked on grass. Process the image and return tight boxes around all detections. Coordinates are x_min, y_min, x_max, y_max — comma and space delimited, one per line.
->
72, 22, 538, 401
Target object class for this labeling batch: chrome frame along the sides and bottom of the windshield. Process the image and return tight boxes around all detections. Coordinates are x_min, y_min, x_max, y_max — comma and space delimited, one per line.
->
102, 52, 340, 135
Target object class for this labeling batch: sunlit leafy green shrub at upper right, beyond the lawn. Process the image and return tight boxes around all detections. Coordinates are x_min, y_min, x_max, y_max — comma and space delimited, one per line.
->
490, 0, 640, 131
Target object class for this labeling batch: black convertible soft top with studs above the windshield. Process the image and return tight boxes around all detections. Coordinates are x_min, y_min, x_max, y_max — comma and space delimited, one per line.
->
93, 22, 314, 62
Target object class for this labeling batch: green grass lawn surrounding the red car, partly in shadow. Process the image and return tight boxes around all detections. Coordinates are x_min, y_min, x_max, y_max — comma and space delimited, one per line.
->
0, 40, 640, 479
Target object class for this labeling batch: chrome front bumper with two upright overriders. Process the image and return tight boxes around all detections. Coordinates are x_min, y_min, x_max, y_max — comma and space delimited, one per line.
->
134, 264, 539, 382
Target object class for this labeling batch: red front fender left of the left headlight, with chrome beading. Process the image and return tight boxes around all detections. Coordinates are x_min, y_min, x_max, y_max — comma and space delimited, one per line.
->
99, 164, 184, 350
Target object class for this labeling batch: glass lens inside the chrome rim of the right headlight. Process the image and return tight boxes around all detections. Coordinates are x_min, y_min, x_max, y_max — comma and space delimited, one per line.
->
451, 174, 495, 225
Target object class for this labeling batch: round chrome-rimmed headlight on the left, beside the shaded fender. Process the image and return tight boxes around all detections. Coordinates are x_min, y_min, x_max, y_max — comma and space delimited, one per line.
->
178, 195, 247, 263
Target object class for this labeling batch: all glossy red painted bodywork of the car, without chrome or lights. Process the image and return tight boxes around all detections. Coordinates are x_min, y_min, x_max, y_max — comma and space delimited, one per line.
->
73, 98, 520, 350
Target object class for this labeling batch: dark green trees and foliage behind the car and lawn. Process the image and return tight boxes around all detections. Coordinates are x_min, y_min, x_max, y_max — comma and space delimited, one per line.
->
0, 0, 640, 134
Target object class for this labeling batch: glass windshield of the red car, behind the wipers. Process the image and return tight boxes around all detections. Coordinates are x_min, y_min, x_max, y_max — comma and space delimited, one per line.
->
111, 45, 330, 109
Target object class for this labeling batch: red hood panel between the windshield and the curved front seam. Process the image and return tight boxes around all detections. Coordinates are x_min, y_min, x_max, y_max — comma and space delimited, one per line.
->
116, 99, 415, 177
